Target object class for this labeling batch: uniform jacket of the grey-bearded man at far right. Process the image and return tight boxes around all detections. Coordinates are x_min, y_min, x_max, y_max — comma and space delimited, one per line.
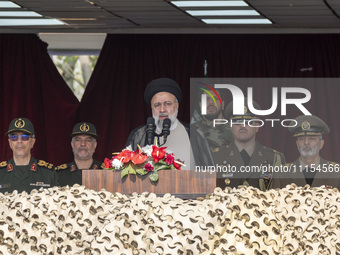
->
273, 157, 340, 190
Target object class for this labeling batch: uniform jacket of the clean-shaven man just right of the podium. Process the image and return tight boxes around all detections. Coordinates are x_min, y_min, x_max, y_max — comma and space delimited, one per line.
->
213, 142, 285, 190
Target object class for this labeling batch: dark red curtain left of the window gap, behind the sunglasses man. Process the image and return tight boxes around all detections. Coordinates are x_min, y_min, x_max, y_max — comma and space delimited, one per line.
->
0, 34, 79, 164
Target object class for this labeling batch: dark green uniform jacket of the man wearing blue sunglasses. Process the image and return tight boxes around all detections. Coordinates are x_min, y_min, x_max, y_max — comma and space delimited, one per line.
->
0, 157, 58, 193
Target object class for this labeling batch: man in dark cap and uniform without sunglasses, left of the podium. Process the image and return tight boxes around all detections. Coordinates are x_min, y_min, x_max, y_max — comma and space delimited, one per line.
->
57, 122, 104, 186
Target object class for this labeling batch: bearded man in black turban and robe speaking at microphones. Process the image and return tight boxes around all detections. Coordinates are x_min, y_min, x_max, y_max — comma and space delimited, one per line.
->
126, 78, 215, 169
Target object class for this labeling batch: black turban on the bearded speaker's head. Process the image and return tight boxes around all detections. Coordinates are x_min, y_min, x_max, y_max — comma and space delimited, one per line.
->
144, 78, 182, 105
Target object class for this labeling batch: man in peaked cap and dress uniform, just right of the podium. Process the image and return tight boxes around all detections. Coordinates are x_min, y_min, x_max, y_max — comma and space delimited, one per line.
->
213, 100, 285, 191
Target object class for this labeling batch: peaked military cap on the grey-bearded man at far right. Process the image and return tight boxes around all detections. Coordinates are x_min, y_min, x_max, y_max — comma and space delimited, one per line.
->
288, 115, 330, 137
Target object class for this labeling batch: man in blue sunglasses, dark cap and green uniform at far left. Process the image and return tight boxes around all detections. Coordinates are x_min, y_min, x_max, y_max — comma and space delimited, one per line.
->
0, 118, 58, 193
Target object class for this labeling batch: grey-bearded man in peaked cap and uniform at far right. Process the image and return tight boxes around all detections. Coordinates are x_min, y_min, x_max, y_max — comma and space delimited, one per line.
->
273, 115, 340, 189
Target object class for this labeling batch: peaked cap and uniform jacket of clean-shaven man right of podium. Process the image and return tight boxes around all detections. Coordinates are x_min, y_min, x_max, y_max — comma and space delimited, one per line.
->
212, 99, 285, 191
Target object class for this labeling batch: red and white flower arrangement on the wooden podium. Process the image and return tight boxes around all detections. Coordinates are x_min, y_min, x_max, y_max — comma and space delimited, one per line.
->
104, 145, 184, 182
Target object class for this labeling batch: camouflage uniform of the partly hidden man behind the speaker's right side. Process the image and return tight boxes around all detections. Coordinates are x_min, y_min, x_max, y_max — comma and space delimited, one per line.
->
193, 118, 233, 150
